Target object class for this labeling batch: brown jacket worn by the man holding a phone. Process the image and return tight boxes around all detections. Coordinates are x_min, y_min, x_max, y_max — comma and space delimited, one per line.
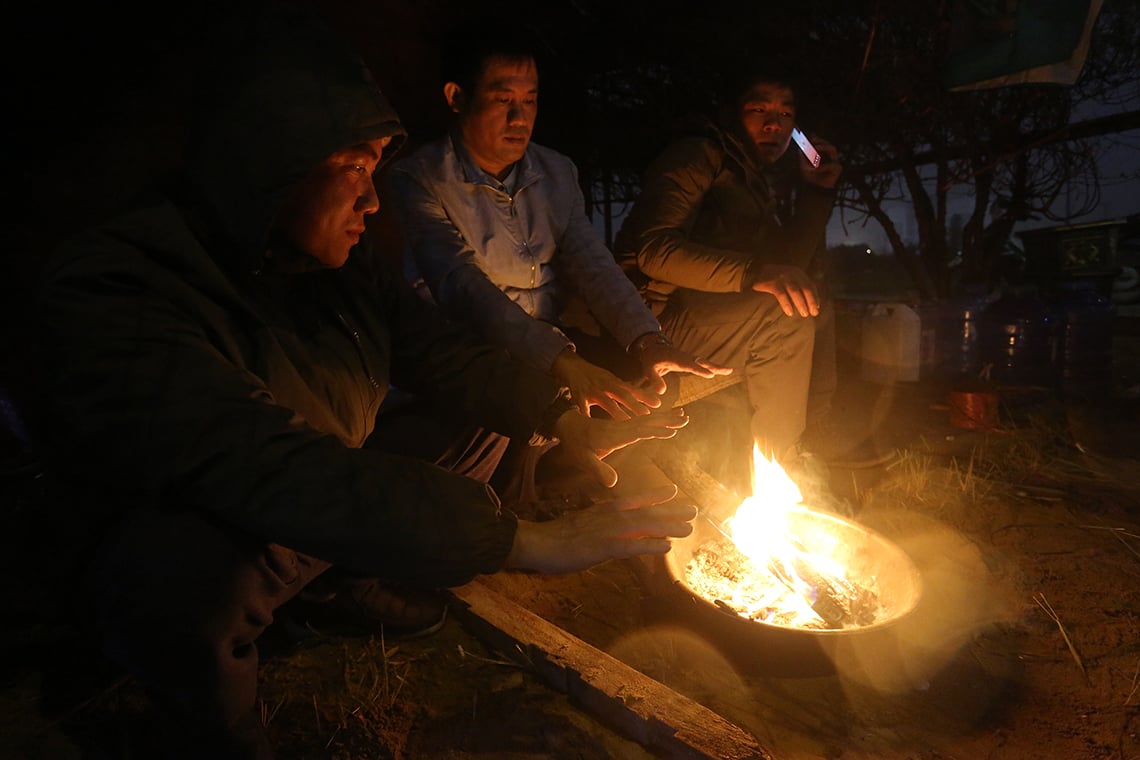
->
613, 121, 834, 310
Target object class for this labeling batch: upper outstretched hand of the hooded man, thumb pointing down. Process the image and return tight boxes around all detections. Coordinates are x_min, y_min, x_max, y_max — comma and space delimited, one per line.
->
554, 408, 689, 488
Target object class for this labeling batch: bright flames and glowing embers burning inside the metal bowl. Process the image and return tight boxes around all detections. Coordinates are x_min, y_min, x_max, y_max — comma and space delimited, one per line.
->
685, 450, 881, 629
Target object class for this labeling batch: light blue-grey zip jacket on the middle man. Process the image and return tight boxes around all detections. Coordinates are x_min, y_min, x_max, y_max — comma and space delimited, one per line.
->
388, 136, 660, 378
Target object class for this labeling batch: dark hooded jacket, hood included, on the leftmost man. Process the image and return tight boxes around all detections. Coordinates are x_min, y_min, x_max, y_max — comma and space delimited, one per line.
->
25, 2, 560, 586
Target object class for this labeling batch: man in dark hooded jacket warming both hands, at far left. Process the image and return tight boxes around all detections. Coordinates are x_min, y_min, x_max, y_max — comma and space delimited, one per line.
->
29, 3, 694, 758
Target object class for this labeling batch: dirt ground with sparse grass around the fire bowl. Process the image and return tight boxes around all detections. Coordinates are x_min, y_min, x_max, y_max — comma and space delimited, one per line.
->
0, 335, 1140, 760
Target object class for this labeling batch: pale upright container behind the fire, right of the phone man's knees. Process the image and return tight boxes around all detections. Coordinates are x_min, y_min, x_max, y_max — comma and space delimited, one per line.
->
860, 303, 922, 384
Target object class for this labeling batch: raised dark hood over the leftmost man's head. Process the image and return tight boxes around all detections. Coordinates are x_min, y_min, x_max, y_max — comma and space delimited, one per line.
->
186, 3, 406, 269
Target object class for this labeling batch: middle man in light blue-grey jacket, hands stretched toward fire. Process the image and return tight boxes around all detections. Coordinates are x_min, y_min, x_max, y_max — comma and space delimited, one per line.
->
388, 18, 731, 505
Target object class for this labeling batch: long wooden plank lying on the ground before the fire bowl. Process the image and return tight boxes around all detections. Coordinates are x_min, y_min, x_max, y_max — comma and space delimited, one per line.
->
451, 579, 772, 760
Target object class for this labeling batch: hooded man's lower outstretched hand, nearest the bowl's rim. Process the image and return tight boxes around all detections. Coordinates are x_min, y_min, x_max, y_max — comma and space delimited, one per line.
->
505, 484, 697, 573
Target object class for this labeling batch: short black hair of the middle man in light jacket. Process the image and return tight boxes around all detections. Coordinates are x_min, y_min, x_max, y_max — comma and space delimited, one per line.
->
440, 17, 539, 92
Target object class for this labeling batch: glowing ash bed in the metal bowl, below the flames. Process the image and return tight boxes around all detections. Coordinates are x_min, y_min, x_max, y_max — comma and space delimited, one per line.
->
685, 538, 881, 630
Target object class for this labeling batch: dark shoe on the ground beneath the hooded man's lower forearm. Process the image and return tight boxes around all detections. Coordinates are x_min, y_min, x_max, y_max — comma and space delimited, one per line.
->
293, 571, 447, 640
